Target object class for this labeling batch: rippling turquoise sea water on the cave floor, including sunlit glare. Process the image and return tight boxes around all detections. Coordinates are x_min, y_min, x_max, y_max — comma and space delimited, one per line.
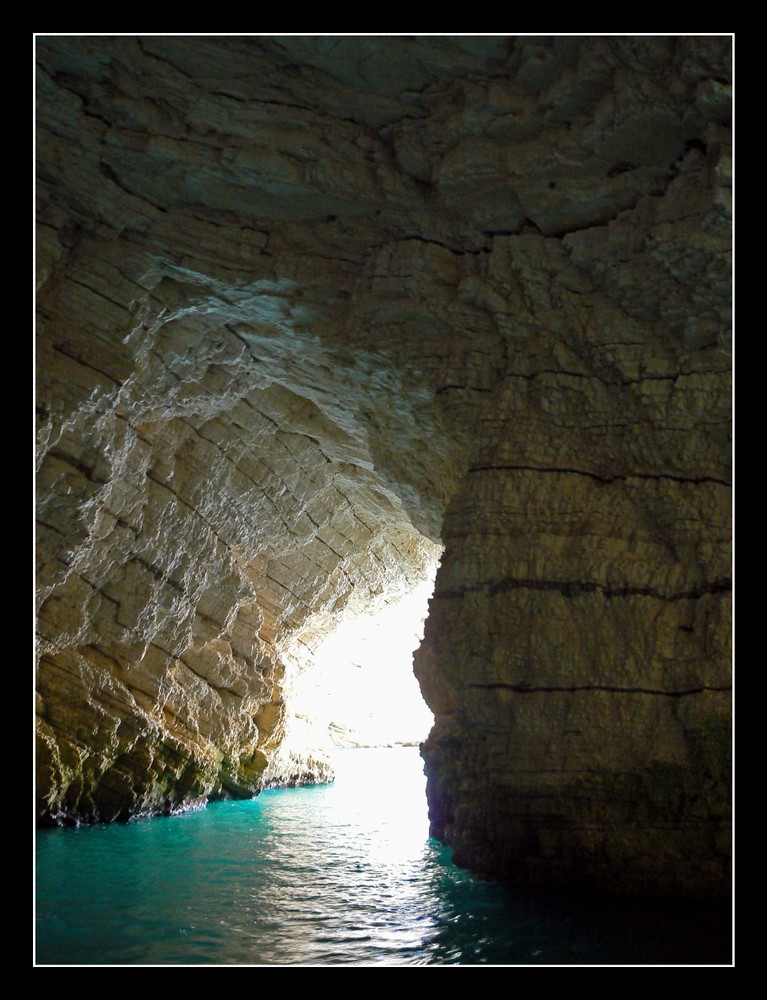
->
36, 749, 730, 965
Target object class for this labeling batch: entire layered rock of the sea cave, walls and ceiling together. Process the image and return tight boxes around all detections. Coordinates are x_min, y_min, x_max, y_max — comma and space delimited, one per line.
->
37, 37, 730, 895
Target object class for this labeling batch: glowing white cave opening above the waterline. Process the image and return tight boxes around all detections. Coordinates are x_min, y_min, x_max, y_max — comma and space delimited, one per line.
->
290, 562, 437, 751
